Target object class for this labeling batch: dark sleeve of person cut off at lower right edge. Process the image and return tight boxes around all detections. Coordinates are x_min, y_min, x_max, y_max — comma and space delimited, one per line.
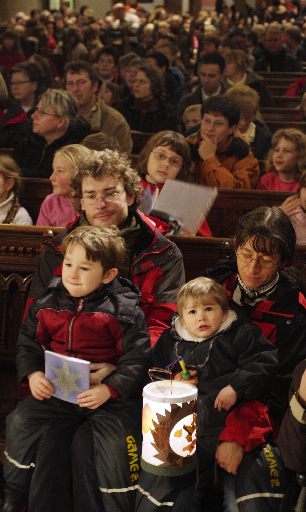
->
277, 360, 306, 473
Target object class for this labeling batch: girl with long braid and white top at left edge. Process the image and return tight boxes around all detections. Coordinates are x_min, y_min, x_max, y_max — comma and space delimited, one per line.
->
0, 155, 33, 225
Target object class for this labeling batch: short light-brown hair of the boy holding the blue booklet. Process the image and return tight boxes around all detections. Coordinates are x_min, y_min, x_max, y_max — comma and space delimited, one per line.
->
61, 226, 125, 272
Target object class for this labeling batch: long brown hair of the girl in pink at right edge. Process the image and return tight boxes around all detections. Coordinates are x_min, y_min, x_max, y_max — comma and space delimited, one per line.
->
265, 128, 306, 177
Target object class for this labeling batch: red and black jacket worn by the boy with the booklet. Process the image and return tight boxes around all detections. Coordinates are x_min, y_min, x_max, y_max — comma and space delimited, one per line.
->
17, 278, 151, 398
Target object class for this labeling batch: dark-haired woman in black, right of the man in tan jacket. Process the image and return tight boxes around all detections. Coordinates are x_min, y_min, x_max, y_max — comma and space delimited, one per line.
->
118, 65, 178, 133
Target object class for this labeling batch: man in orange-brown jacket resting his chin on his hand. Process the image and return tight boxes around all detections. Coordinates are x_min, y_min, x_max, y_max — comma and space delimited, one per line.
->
187, 96, 259, 189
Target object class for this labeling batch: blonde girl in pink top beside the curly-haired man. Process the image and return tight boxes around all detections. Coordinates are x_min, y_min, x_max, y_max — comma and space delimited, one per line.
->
36, 144, 91, 226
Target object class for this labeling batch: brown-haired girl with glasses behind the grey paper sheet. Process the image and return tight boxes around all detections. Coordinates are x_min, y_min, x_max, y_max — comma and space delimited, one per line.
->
137, 130, 211, 236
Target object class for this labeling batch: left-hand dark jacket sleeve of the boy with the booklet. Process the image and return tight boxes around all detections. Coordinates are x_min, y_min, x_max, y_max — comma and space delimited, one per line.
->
16, 303, 45, 382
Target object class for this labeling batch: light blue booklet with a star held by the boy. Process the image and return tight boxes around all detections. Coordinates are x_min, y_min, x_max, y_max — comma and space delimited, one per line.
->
45, 350, 90, 404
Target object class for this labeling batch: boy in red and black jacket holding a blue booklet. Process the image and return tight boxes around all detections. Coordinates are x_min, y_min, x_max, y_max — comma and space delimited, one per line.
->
2, 226, 150, 512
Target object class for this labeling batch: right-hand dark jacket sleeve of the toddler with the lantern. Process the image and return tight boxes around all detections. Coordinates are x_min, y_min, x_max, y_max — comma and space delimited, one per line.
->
231, 322, 278, 400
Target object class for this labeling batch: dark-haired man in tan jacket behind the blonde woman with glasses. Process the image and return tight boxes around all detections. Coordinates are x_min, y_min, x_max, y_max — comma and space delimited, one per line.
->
64, 61, 133, 153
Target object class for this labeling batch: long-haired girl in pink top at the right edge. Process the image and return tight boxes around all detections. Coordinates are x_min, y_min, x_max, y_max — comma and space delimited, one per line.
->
257, 128, 306, 192
